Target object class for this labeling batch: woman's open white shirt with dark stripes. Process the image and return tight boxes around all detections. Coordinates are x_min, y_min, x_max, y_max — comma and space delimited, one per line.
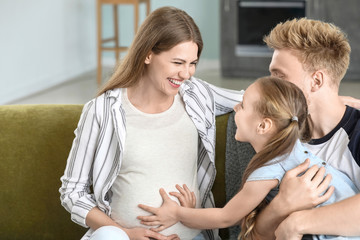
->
59, 77, 244, 240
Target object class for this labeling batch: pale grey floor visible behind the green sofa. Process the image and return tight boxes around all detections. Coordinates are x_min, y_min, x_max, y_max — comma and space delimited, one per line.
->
9, 69, 360, 104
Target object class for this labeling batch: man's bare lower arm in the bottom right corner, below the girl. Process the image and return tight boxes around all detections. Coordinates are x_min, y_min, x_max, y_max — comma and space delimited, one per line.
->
275, 194, 360, 240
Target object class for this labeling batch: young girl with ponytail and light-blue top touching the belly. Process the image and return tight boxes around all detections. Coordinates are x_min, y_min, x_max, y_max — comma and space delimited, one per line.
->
138, 77, 359, 239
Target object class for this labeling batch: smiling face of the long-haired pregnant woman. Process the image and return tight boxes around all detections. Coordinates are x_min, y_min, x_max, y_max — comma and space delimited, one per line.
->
143, 41, 198, 96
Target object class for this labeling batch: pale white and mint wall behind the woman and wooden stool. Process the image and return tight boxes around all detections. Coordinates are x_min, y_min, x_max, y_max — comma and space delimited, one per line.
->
0, 0, 219, 104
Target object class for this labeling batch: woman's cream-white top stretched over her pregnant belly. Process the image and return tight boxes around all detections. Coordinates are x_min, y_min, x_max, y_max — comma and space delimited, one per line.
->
110, 89, 200, 239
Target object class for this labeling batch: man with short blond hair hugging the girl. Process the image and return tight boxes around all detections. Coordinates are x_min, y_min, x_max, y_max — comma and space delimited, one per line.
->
255, 18, 360, 240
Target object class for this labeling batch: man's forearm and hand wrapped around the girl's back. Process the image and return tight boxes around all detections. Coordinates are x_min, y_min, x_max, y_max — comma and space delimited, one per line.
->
255, 159, 334, 239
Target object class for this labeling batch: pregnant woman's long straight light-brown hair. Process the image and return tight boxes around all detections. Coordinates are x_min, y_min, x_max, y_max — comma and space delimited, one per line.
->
98, 7, 203, 95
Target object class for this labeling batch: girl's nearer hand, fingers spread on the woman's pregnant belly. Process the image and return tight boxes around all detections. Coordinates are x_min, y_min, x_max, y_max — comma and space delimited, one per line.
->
137, 188, 180, 232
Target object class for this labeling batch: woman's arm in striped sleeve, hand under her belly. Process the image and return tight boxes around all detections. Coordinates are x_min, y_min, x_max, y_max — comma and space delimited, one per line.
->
59, 100, 177, 240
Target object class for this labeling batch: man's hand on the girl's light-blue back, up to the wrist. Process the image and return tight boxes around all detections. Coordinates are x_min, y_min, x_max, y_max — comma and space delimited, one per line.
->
276, 159, 334, 215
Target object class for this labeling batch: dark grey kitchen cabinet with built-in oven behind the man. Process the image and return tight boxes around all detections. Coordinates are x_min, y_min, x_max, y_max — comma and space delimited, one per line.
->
220, 0, 360, 80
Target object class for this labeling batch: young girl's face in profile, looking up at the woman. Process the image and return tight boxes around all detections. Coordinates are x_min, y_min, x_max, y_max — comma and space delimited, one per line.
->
234, 83, 262, 146
